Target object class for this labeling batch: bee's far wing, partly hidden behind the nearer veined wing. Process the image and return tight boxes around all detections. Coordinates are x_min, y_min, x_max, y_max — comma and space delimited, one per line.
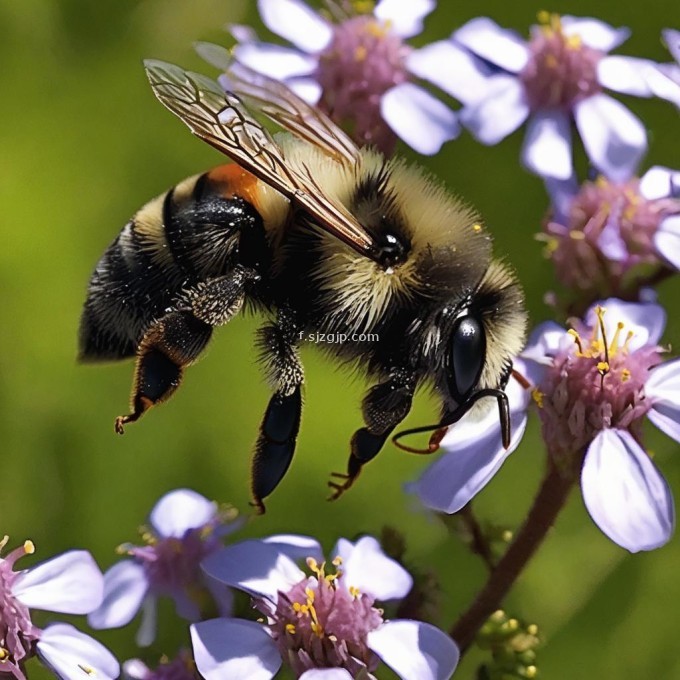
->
196, 43, 359, 165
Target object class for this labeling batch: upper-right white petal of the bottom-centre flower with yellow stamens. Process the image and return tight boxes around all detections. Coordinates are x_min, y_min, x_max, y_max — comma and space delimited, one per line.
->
330, 536, 413, 602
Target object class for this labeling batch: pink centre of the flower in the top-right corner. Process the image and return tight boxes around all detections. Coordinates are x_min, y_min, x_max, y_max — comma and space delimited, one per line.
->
520, 12, 604, 110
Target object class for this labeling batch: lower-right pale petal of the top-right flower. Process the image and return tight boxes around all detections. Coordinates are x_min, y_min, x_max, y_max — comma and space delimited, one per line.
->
574, 93, 647, 182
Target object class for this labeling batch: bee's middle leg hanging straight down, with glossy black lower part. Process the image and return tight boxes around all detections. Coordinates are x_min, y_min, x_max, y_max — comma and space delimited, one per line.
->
251, 311, 304, 513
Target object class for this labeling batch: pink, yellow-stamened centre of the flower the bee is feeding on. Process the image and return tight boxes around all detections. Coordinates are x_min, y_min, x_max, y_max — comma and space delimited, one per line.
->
533, 307, 661, 457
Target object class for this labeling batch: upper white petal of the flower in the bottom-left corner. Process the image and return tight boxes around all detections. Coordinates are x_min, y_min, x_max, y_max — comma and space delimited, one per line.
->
12, 550, 104, 614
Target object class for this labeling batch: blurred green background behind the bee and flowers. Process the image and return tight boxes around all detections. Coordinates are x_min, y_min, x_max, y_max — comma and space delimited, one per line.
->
0, 0, 680, 680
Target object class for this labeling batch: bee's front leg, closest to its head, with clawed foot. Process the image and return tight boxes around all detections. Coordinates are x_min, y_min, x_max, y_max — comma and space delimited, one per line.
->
328, 371, 417, 500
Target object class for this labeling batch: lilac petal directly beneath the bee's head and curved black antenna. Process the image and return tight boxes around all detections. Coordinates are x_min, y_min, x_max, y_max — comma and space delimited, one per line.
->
411, 380, 529, 514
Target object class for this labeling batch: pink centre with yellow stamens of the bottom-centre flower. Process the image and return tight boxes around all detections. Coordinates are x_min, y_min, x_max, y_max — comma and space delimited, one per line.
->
257, 559, 383, 677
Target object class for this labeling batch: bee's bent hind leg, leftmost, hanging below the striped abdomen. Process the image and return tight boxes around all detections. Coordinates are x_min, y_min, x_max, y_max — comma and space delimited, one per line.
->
116, 265, 257, 434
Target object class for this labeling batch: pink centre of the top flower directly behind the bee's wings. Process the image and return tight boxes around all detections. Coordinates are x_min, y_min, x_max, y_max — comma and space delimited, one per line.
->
316, 15, 410, 152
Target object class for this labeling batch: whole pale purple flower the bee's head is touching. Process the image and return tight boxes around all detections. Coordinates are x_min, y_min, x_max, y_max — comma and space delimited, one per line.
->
413, 299, 680, 552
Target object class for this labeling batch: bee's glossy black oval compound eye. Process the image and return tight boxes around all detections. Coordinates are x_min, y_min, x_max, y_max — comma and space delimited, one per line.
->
448, 315, 486, 400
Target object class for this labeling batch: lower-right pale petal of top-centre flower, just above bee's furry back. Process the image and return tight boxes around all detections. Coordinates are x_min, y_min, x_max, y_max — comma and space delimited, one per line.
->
380, 83, 460, 155
